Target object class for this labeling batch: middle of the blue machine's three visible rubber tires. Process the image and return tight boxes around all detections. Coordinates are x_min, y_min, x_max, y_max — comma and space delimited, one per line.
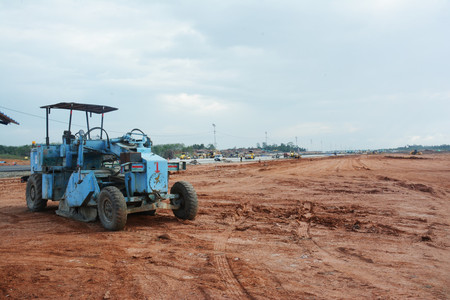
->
97, 186, 128, 231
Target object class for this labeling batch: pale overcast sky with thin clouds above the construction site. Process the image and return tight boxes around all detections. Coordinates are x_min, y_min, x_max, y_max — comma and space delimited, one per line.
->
0, 0, 450, 150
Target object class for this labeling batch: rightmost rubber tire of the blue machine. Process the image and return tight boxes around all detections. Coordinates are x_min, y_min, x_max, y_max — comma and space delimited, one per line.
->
170, 181, 198, 220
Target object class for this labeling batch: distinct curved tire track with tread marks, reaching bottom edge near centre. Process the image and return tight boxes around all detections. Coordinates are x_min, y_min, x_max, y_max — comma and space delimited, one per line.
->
214, 224, 249, 299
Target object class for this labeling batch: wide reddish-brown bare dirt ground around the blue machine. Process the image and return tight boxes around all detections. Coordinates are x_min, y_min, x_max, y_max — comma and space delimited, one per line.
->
0, 154, 450, 299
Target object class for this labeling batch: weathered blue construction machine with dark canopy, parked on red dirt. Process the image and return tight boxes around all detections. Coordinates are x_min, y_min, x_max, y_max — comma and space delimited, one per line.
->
23, 102, 198, 230
